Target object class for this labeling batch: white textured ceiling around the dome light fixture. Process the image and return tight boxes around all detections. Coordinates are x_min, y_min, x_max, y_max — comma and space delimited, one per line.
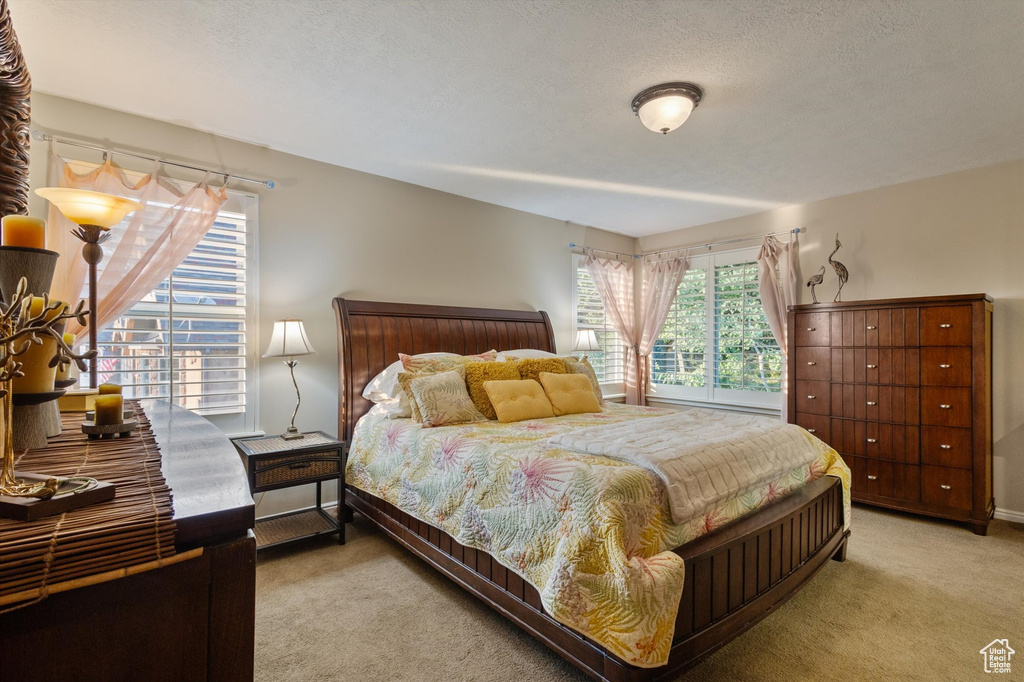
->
10, 0, 1024, 236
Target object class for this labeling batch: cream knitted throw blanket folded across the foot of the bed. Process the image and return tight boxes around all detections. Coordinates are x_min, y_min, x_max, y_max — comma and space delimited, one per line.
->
548, 410, 829, 523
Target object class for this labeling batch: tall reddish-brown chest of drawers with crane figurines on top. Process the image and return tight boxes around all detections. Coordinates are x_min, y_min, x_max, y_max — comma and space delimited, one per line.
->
788, 294, 994, 535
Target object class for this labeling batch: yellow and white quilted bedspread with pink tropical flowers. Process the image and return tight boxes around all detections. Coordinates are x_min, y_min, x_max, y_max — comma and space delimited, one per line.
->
346, 404, 850, 668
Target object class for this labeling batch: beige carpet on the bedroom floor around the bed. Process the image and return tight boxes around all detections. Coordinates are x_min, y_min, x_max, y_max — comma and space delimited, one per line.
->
256, 506, 1024, 682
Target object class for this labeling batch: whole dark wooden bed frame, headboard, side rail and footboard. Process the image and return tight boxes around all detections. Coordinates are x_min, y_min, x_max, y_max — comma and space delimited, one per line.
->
334, 298, 849, 682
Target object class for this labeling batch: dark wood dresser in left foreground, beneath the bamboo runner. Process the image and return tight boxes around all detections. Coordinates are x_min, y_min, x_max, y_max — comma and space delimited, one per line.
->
0, 401, 256, 682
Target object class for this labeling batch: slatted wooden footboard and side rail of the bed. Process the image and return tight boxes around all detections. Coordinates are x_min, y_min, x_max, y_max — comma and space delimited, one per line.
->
345, 476, 849, 682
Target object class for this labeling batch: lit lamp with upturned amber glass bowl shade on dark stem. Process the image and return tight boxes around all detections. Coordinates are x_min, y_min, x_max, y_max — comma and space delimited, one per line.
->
36, 187, 142, 389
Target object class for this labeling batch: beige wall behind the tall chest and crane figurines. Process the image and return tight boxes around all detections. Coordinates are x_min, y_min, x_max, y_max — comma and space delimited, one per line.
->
639, 161, 1024, 520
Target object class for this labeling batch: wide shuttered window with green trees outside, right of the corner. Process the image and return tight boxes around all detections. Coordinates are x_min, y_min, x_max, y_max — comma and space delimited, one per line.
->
650, 249, 782, 407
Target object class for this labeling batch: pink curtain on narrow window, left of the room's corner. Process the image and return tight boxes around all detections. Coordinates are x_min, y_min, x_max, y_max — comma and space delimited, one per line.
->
584, 249, 641, 404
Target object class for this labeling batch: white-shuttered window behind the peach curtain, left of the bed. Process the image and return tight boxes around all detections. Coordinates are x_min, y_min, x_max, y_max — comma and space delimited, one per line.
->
70, 164, 257, 433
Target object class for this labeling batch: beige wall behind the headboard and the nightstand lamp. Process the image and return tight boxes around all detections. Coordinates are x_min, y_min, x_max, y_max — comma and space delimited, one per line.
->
25, 93, 634, 514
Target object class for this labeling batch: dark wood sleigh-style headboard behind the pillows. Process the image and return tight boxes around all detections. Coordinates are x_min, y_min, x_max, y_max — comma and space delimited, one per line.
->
334, 298, 555, 440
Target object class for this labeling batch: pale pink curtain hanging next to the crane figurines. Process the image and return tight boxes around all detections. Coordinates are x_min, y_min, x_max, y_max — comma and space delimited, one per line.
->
758, 236, 799, 422
